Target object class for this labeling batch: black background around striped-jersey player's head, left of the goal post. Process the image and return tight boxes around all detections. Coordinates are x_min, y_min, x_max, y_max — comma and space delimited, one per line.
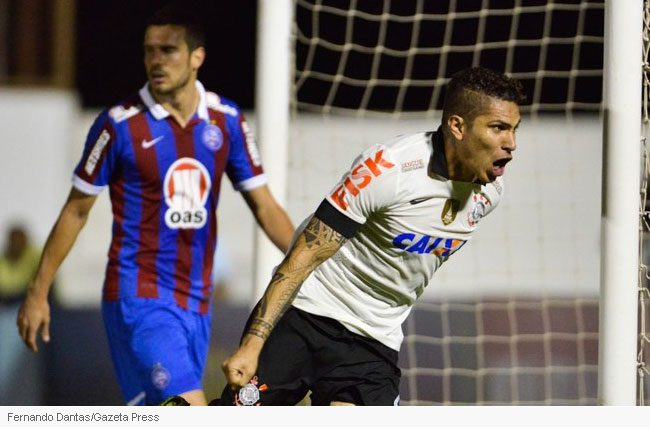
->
76, 0, 257, 109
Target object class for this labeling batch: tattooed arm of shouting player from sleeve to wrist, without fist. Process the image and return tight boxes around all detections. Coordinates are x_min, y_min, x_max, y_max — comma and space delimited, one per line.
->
247, 217, 346, 340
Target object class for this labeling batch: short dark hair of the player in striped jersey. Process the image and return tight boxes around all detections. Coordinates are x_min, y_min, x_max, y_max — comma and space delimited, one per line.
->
145, 1, 205, 51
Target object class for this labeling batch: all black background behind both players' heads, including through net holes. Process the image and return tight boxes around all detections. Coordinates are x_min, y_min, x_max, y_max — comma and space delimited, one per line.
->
76, 0, 604, 110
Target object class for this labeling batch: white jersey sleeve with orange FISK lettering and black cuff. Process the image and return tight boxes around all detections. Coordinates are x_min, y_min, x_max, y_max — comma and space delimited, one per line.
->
315, 145, 398, 238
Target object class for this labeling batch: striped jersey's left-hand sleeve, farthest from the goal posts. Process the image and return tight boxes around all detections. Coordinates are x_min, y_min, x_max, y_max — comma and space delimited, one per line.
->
72, 111, 118, 195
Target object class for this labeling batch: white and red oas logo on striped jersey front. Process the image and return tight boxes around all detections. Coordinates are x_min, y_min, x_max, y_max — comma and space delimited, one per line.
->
164, 158, 212, 229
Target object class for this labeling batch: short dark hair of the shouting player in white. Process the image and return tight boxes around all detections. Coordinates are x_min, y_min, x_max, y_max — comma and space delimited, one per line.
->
442, 67, 526, 124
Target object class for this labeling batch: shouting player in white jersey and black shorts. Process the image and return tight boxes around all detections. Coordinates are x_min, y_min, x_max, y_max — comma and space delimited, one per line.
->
221, 68, 524, 405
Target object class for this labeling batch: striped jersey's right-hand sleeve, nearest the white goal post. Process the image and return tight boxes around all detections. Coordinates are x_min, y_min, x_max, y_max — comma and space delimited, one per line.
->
226, 109, 267, 191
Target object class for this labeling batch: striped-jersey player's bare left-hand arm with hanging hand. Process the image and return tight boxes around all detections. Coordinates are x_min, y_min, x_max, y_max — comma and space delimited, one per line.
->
16, 188, 97, 352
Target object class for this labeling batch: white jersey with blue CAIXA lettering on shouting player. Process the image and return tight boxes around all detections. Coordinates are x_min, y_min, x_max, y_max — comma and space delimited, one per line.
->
293, 131, 503, 350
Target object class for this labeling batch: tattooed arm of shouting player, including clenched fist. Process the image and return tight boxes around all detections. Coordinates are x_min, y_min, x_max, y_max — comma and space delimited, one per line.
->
222, 216, 345, 388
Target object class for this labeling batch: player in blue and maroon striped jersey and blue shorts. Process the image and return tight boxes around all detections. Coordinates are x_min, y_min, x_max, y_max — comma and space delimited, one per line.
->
17, 3, 293, 405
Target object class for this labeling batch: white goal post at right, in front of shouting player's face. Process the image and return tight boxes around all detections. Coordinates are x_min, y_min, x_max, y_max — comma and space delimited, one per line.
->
598, 0, 644, 405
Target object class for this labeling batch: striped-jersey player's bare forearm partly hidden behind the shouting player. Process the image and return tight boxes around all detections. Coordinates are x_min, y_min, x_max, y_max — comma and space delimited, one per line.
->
242, 185, 294, 253
